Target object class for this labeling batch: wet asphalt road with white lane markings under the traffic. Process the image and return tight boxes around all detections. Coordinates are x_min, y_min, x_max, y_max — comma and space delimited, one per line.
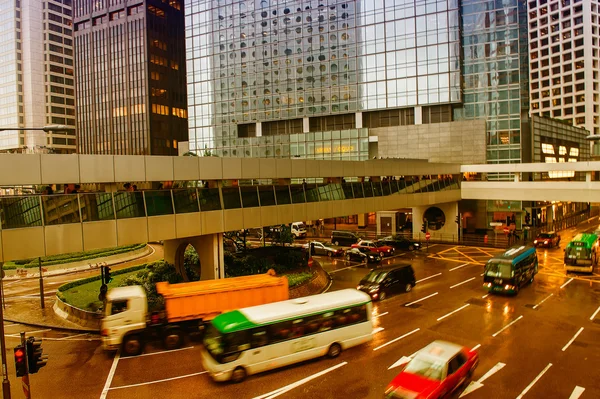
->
2, 233, 600, 399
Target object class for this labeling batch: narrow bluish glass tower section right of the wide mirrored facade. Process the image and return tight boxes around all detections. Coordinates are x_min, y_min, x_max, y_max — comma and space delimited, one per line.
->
454, 0, 530, 163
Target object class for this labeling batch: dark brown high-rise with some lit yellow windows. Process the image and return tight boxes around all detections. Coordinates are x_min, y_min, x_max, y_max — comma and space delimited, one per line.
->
74, 0, 188, 155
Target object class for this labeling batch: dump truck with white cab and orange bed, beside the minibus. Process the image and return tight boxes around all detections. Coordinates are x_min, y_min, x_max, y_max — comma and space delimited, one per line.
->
102, 271, 289, 356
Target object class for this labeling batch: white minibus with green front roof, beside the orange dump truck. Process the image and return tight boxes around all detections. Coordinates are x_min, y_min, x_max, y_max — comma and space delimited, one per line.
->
202, 289, 373, 382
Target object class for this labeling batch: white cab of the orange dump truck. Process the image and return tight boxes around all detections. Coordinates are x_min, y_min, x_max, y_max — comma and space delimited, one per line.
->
101, 285, 148, 350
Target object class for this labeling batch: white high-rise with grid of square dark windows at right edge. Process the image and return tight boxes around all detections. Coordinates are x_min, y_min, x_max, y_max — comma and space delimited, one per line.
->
527, 0, 600, 135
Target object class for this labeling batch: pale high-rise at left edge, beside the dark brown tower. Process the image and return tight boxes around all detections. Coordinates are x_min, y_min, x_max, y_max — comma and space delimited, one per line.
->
0, 0, 76, 153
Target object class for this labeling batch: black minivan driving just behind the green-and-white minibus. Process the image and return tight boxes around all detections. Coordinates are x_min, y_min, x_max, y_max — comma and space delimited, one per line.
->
356, 264, 417, 300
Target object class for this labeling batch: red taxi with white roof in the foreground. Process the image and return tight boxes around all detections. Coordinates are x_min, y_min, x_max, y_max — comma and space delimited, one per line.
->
385, 341, 479, 399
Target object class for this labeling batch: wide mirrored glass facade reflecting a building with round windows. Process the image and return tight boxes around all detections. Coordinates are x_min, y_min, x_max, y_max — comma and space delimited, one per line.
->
186, 0, 461, 159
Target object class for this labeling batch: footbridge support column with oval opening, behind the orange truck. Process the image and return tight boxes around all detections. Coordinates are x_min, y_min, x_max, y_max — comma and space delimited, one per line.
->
164, 233, 225, 281
